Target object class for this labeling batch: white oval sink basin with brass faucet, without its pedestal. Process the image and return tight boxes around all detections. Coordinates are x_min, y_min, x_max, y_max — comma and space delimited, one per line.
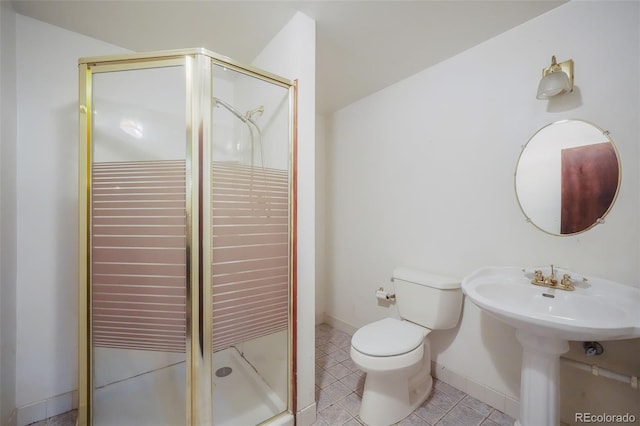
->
462, 267, 640, 340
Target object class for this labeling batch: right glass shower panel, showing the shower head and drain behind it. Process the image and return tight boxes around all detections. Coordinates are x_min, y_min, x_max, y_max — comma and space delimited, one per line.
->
211, 65, 291, 426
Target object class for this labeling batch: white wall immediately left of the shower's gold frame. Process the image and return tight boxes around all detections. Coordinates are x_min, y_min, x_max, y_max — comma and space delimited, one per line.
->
15, 15, 126, 412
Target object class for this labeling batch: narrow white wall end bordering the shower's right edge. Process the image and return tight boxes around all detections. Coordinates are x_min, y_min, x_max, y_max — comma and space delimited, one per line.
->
253, 13, 316, 425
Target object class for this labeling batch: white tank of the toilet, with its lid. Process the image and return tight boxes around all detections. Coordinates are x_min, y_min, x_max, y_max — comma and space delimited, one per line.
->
393, 267, 462, 330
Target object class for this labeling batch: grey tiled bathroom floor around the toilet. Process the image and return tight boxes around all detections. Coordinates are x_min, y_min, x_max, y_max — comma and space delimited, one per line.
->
316, 324, 514, 426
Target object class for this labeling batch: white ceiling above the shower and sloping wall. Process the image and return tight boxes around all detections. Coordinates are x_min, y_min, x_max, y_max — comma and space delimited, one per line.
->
13, 0, 565, 113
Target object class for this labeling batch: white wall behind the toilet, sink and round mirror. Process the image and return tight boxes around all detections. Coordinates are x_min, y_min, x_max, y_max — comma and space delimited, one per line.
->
325, 1, 640, 420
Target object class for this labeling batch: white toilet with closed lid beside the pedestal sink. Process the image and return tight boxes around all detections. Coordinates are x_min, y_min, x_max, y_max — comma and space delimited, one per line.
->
351, 268, 462, 426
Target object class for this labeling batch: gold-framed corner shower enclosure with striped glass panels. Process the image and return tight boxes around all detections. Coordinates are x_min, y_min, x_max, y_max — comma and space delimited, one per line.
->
79, 49, 296, 426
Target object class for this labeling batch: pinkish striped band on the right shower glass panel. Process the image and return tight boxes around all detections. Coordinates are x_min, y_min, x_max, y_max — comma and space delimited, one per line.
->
212, 162, 289, 351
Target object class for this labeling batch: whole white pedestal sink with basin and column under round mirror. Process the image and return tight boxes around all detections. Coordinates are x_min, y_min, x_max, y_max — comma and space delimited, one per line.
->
462, 267, 640, 426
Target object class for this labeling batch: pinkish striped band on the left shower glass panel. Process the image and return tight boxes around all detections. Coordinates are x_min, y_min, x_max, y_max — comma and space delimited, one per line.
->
92, 160, 186, 352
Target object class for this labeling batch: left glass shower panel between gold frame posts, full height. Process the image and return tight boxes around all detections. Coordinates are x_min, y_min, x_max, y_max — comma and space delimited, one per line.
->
90, 64, 187, 426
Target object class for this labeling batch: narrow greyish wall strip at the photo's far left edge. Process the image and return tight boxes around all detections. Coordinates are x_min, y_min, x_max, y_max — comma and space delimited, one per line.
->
0, 2, 17, 426
